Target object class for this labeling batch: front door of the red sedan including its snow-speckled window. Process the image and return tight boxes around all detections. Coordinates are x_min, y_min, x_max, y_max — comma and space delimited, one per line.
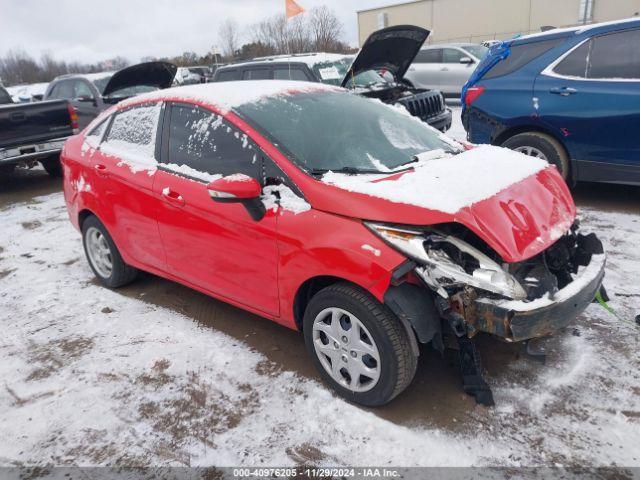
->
153, 105, 279, 316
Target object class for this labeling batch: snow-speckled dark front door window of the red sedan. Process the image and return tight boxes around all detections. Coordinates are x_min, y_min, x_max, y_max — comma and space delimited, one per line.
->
163, 104, 260, 181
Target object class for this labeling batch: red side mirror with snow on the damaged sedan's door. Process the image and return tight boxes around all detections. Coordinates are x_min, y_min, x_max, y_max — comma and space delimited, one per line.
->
207, 173, 267, 221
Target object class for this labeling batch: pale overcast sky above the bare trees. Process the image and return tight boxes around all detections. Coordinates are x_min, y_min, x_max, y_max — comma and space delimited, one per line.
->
0, 0, 394, 62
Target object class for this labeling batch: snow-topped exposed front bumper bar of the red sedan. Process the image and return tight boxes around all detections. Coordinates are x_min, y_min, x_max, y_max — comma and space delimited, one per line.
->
458, 254, 606, 342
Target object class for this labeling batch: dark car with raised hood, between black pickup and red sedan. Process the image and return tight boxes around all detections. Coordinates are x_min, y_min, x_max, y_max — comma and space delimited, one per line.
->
44, 62, 177, 128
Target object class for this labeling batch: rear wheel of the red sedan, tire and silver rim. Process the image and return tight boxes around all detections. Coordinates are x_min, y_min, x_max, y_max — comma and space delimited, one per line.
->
82, 216, 138, 288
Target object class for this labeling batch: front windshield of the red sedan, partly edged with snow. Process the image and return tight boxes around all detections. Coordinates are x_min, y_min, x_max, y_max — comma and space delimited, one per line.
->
236, 91, 453, 173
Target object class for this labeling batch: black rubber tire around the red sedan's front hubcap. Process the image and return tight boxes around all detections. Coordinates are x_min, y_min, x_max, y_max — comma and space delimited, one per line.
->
303, 283, 418, 406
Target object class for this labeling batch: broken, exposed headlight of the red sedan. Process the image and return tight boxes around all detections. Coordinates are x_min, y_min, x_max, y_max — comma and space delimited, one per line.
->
366, 223, 527, 300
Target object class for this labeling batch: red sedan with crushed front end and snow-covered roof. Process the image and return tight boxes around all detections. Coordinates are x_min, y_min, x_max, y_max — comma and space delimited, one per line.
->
62, 80, 605, 405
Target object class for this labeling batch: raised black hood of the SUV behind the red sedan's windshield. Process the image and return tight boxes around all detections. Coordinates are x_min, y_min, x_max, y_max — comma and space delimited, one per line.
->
342, 25, 431, 87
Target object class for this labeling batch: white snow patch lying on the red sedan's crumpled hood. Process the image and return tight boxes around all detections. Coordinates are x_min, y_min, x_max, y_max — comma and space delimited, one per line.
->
322, 145, 549, 214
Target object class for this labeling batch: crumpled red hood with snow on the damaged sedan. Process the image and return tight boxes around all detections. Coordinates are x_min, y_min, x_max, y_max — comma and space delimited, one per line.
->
304, 146, 576, 262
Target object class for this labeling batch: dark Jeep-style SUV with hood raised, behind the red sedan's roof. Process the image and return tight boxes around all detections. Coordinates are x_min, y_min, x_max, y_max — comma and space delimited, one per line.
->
213, 25, 451, 132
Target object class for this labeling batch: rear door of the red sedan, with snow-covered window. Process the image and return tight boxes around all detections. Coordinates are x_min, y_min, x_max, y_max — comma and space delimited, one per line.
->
89, 104, 166, 270
